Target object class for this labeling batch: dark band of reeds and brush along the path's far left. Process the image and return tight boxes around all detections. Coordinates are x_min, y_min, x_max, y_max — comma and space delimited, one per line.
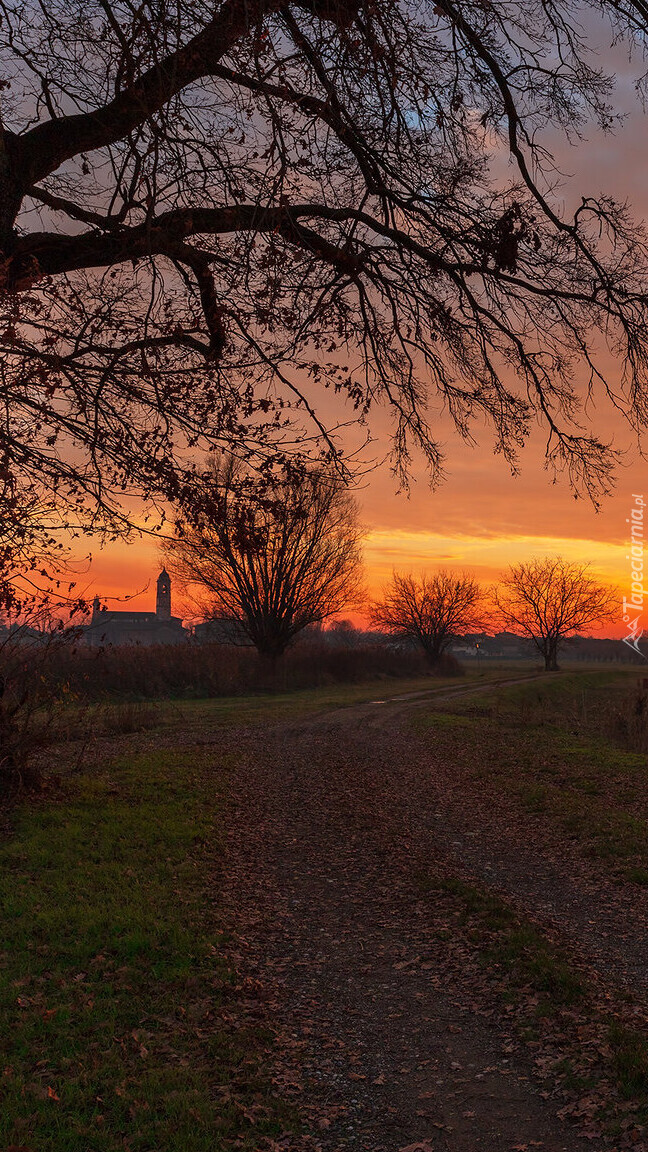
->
0, 634, 462, 803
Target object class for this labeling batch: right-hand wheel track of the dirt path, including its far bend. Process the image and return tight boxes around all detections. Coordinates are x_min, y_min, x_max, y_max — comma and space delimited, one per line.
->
289, 676, 648, 1002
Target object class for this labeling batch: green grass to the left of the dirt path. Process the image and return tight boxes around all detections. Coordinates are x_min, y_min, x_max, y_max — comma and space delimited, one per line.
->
0, 750, 286, 1152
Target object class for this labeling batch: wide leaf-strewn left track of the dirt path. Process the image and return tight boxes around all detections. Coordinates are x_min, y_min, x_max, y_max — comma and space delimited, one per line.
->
216, 677, 612, 1152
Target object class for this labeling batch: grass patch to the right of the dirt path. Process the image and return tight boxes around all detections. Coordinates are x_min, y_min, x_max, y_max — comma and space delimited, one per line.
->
413, 670, 648, 884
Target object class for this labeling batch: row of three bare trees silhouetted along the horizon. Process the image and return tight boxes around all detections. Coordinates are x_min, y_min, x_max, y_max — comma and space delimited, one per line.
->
165, 454, 618, 672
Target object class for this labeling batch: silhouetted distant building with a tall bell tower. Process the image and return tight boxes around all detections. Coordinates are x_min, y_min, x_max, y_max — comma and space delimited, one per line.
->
83, 568, 189, 647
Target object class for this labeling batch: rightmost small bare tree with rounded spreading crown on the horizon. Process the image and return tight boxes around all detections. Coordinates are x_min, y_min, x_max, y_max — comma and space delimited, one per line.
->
493, 556, 618, 672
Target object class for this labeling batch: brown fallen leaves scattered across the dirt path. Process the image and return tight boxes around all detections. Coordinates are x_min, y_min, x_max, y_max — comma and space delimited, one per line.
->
201, 681, 648, 1152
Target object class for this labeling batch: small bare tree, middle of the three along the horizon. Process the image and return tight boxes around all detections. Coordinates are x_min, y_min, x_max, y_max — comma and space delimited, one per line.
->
371, 570, 483, 666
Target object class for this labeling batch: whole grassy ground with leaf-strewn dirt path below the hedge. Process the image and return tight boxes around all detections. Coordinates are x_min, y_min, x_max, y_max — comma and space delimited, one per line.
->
0, 666, 648, 1152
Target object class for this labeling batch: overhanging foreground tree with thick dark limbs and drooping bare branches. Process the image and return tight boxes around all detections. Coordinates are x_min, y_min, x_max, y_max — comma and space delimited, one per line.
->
5, 0, 648, 552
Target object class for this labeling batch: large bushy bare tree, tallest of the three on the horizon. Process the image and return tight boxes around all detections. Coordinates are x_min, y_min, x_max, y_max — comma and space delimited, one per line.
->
166, 456, 362, 661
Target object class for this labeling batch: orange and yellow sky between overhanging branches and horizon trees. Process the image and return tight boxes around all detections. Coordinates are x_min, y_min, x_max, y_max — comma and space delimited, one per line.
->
81, 426, 648, 636
